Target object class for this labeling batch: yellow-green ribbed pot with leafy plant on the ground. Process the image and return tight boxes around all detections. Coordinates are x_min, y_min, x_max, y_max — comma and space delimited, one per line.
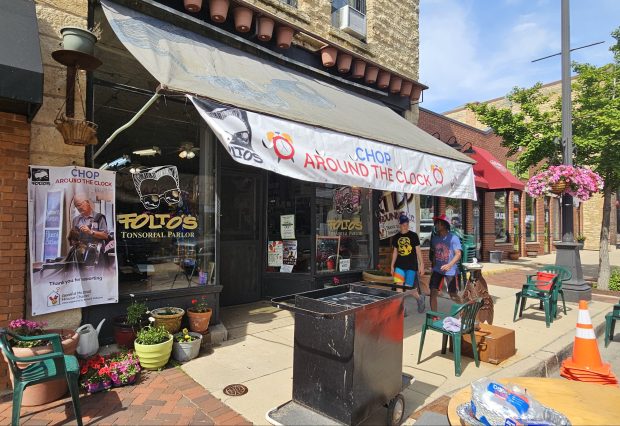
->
134, 325, 172, 370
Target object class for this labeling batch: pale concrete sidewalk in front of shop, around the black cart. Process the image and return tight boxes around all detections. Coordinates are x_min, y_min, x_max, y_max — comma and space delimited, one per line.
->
182, 266, 617, 424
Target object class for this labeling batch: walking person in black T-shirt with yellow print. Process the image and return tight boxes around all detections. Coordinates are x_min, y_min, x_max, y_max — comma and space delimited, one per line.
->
392, 214, 425, 313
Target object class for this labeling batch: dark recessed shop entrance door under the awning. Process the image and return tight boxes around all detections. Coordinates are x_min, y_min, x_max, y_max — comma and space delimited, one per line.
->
219, 168, 262, 306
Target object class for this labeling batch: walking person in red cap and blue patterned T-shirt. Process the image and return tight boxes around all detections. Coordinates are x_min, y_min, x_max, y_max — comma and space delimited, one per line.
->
430, 214, 462, 311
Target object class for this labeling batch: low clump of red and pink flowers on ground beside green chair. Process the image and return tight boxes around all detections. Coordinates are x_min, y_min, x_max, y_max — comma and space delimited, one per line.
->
80, 351, 141, 393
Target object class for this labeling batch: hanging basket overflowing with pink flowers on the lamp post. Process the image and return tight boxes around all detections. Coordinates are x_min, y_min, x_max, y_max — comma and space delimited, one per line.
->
525, 165, 604, 201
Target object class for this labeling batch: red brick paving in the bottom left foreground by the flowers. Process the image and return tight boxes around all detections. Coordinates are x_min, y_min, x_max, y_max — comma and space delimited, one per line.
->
0, 368, 251, 425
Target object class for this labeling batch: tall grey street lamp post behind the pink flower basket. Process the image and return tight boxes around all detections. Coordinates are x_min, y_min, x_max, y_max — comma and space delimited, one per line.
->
555, 0, 592, 302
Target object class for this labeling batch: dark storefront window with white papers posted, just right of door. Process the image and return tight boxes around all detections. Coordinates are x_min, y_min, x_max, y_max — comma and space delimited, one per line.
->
267, 173, 314, 273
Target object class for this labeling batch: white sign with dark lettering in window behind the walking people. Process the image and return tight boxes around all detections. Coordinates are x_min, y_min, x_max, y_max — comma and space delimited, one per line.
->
379, 191, 417, 240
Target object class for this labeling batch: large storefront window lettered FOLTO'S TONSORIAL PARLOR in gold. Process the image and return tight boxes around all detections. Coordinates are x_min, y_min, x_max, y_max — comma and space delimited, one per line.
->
95, 85, 215, 294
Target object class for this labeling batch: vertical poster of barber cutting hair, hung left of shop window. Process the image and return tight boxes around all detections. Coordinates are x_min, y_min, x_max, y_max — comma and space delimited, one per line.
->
28, 166, 118, 315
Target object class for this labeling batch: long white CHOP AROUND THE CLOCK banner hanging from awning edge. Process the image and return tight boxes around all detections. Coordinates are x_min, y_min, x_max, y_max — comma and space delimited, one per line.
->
188, 96, 476, 200
